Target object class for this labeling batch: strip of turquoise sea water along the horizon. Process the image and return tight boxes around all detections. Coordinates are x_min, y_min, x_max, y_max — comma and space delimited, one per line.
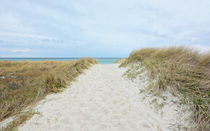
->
0, 58, 119, 64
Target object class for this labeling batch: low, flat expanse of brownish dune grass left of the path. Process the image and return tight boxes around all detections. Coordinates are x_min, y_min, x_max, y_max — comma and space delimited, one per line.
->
0, 58, 97, 121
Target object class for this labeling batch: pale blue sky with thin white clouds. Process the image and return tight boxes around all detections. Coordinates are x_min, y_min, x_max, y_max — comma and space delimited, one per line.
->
0, 0, 210, 57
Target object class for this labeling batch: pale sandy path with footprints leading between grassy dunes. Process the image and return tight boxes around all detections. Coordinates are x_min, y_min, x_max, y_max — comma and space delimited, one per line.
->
19, 64, 166, 131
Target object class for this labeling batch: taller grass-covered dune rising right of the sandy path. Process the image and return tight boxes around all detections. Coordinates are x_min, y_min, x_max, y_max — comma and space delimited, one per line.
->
121, 47, 210, 130
